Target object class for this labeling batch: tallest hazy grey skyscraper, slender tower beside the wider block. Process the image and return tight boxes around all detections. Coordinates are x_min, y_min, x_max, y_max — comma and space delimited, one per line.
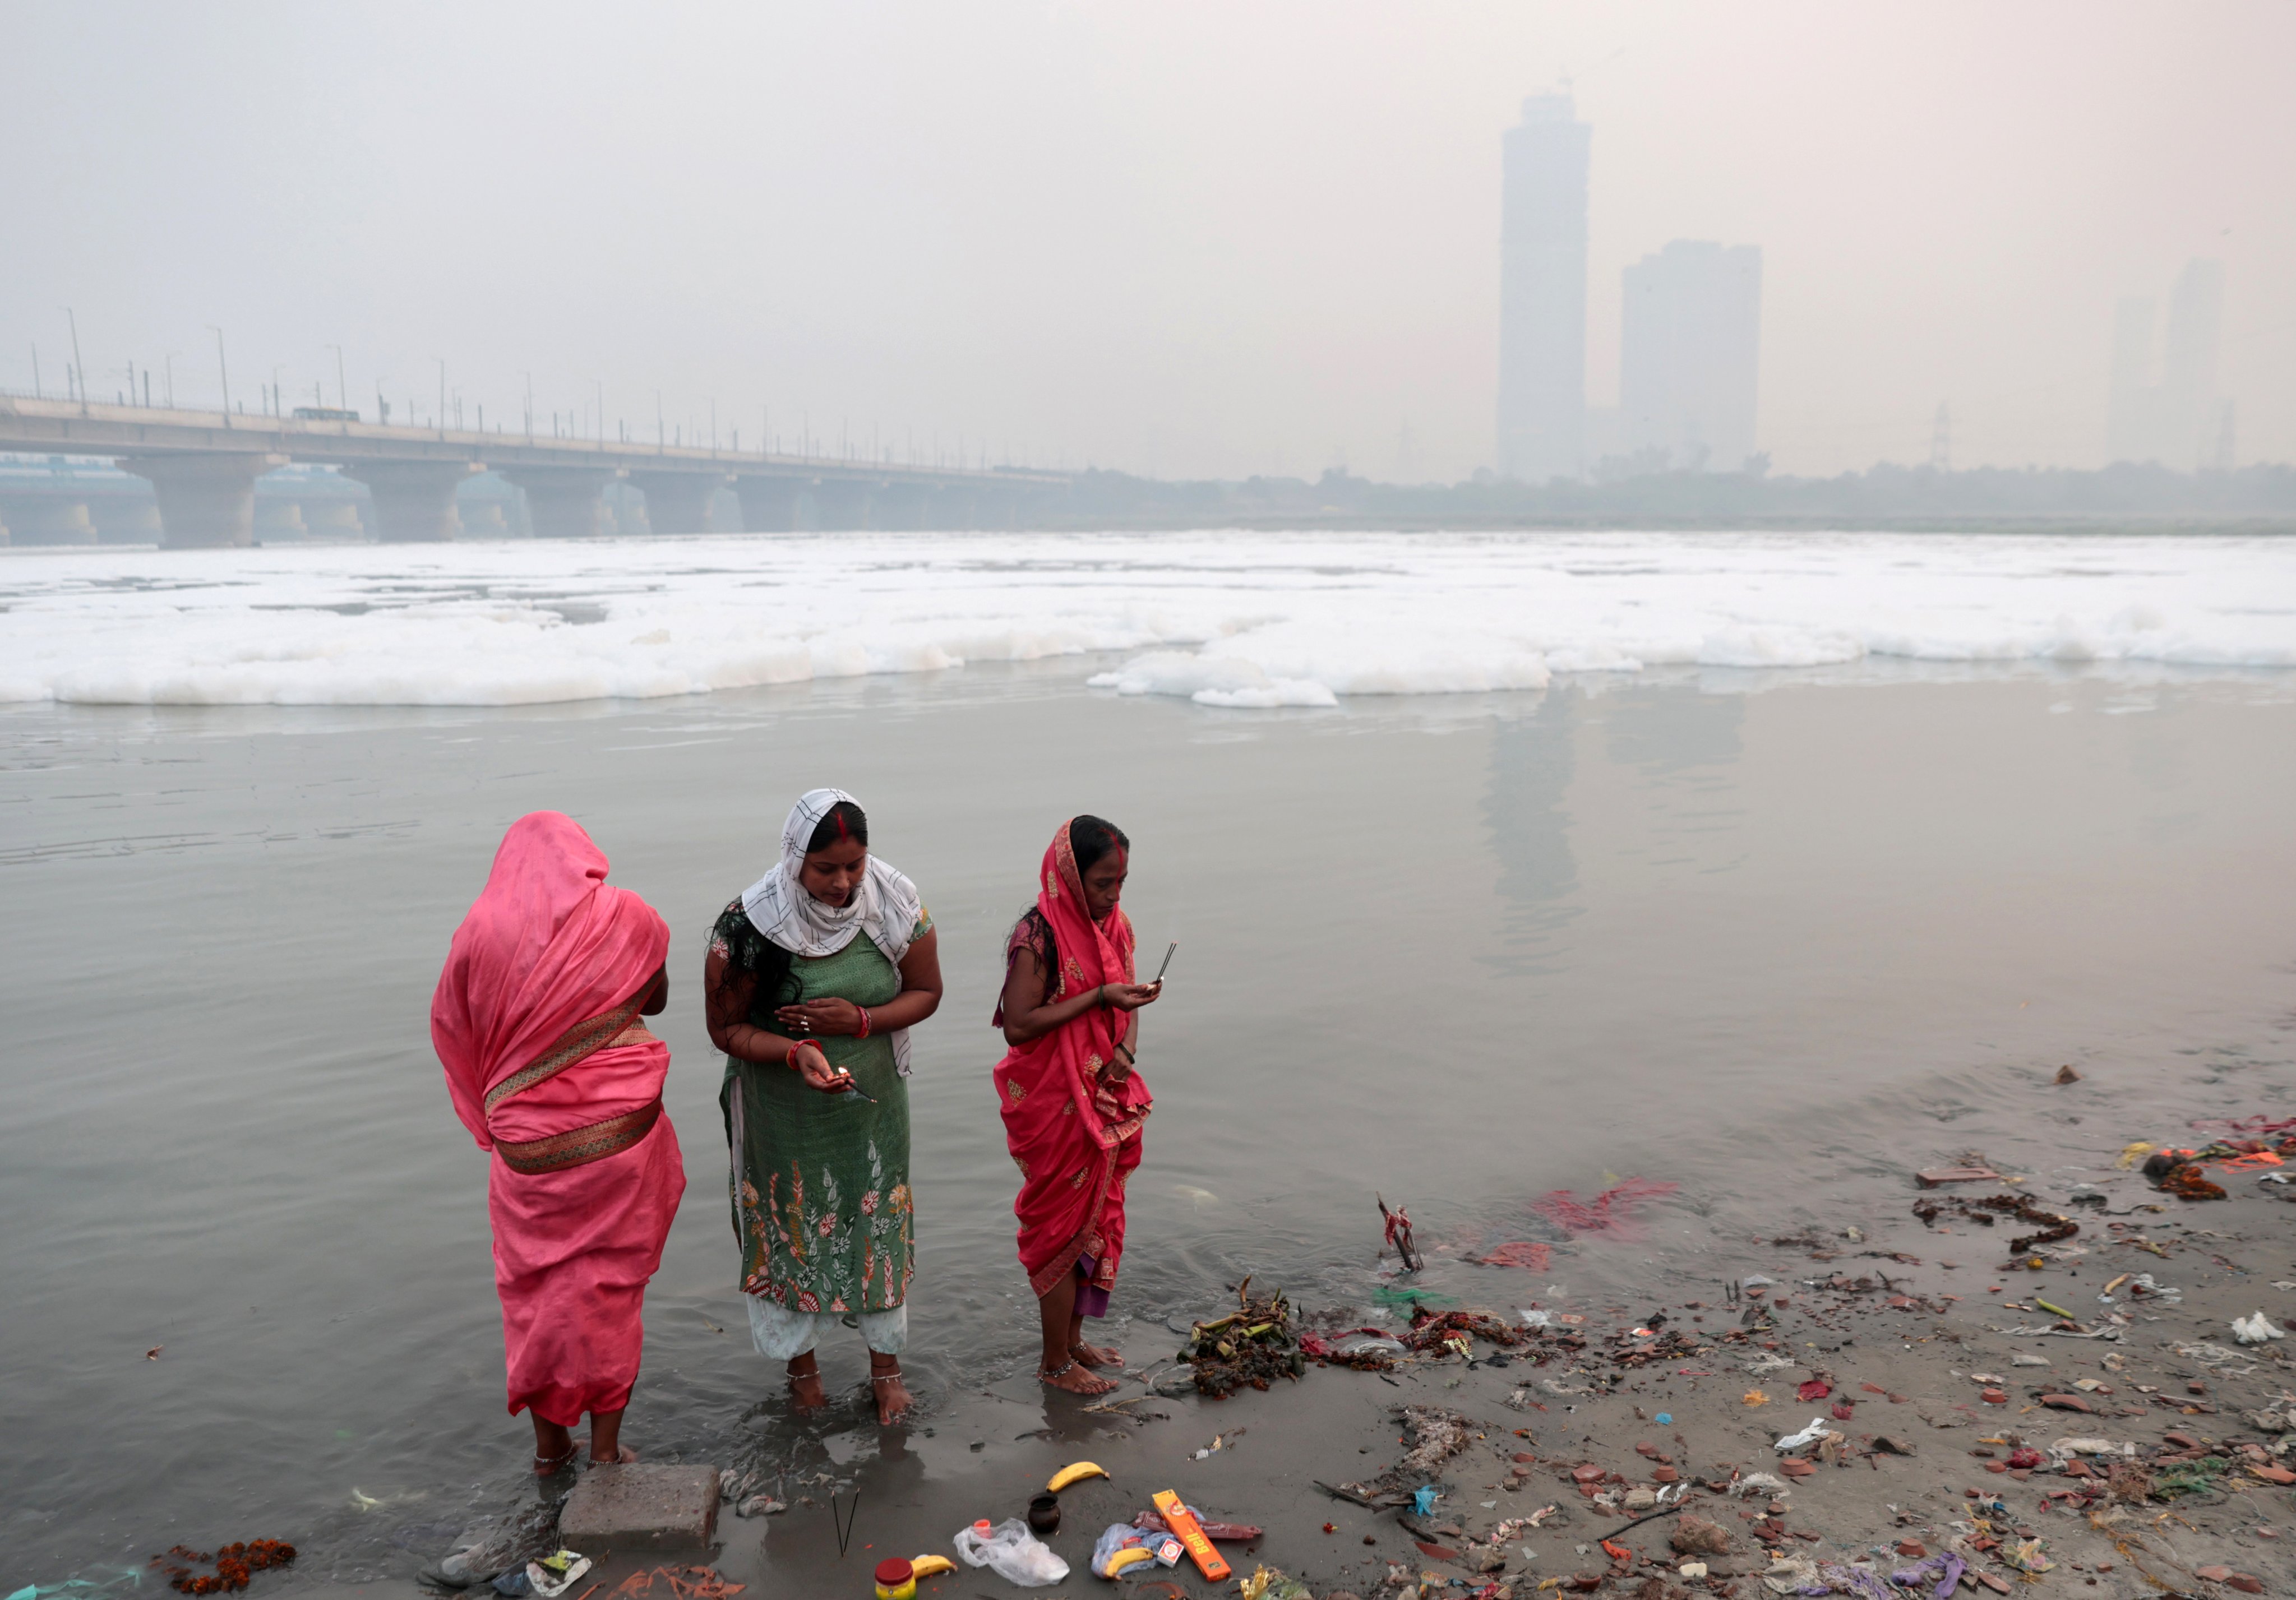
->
1499, 94, 1589, 482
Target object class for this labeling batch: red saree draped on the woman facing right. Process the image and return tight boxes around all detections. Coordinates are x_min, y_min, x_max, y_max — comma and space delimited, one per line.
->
992, 822, 1151, 1297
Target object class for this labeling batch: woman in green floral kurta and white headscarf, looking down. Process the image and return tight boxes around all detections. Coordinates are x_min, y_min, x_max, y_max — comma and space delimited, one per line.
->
703, 790, 941, 1423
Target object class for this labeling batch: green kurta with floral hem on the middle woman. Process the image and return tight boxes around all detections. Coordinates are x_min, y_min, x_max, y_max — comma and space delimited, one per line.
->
719, 914, 932, 1313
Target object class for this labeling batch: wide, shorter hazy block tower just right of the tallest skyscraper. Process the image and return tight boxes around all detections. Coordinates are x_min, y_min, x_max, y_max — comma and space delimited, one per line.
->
1619, 239, 1761, 473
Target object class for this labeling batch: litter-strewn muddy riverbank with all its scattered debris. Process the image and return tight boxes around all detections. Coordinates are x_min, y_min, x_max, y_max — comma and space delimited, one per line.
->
188, 1061, 2296, 1600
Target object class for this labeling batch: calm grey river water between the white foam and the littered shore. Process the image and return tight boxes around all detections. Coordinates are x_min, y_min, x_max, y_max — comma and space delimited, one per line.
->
0, 659, 2296, 1581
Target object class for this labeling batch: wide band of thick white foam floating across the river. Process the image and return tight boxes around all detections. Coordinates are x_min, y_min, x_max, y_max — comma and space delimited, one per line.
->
0, 533, 2296, 709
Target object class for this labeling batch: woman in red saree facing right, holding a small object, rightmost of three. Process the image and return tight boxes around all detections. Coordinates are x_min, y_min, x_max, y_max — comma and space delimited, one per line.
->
994, 817, 1159, 1393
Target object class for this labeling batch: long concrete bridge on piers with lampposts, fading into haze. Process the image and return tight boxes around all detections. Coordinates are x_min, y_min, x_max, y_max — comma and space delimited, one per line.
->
0, 395, 1070, 549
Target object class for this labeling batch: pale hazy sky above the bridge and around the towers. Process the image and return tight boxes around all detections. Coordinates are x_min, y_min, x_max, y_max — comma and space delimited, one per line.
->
0, 0, 2296, 478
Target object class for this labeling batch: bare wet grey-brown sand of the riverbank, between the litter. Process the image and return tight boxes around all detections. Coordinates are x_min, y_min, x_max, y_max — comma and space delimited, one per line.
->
292, 1111, 2296, 1600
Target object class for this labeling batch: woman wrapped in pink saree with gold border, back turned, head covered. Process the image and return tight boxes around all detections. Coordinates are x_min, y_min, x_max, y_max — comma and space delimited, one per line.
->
432, 810, 686, 1474
